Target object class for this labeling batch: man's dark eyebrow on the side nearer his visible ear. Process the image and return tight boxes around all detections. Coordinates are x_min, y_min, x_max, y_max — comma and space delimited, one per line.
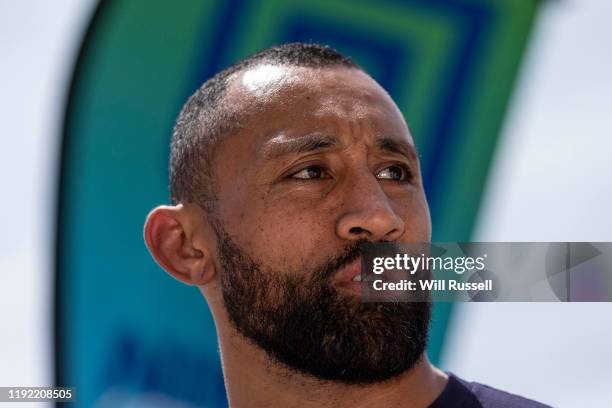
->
262, 134, 341, 160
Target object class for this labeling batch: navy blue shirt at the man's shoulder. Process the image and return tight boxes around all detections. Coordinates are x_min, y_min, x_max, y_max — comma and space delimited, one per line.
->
429, 373, 550, 408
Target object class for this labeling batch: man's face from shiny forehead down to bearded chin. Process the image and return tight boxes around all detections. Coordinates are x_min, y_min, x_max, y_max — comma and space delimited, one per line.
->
206, 65, 431, 383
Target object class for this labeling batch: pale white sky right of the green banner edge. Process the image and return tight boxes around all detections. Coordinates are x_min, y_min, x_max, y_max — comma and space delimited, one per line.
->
444, 0, 612, 408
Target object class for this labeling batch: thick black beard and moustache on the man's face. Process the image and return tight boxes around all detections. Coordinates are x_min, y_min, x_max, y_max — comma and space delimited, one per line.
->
213, 222, 431, 384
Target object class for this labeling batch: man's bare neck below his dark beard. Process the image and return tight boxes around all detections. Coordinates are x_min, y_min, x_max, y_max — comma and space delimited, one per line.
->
217, 321, 448, 408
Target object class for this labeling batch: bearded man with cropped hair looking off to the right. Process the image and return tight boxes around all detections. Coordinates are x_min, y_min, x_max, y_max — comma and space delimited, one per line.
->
145, 44, 541, 408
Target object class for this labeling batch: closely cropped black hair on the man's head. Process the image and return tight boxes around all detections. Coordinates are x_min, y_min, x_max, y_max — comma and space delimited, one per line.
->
170, 43, 361, 213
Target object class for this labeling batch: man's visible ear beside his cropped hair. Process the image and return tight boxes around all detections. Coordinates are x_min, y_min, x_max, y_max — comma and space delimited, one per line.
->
144, 204, 215, 286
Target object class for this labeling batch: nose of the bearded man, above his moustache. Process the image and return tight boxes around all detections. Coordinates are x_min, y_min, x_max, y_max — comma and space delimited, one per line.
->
336, 173, 405, 242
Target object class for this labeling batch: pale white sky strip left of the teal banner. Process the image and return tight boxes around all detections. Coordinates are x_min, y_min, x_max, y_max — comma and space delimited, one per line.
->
0, 0, 95, 408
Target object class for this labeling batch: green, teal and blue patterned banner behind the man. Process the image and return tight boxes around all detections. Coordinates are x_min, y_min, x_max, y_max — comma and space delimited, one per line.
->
55, 0, 538, 407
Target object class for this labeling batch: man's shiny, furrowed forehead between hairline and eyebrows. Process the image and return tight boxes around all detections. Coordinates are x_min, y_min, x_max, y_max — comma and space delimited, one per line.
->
226, 64, 412, 143
